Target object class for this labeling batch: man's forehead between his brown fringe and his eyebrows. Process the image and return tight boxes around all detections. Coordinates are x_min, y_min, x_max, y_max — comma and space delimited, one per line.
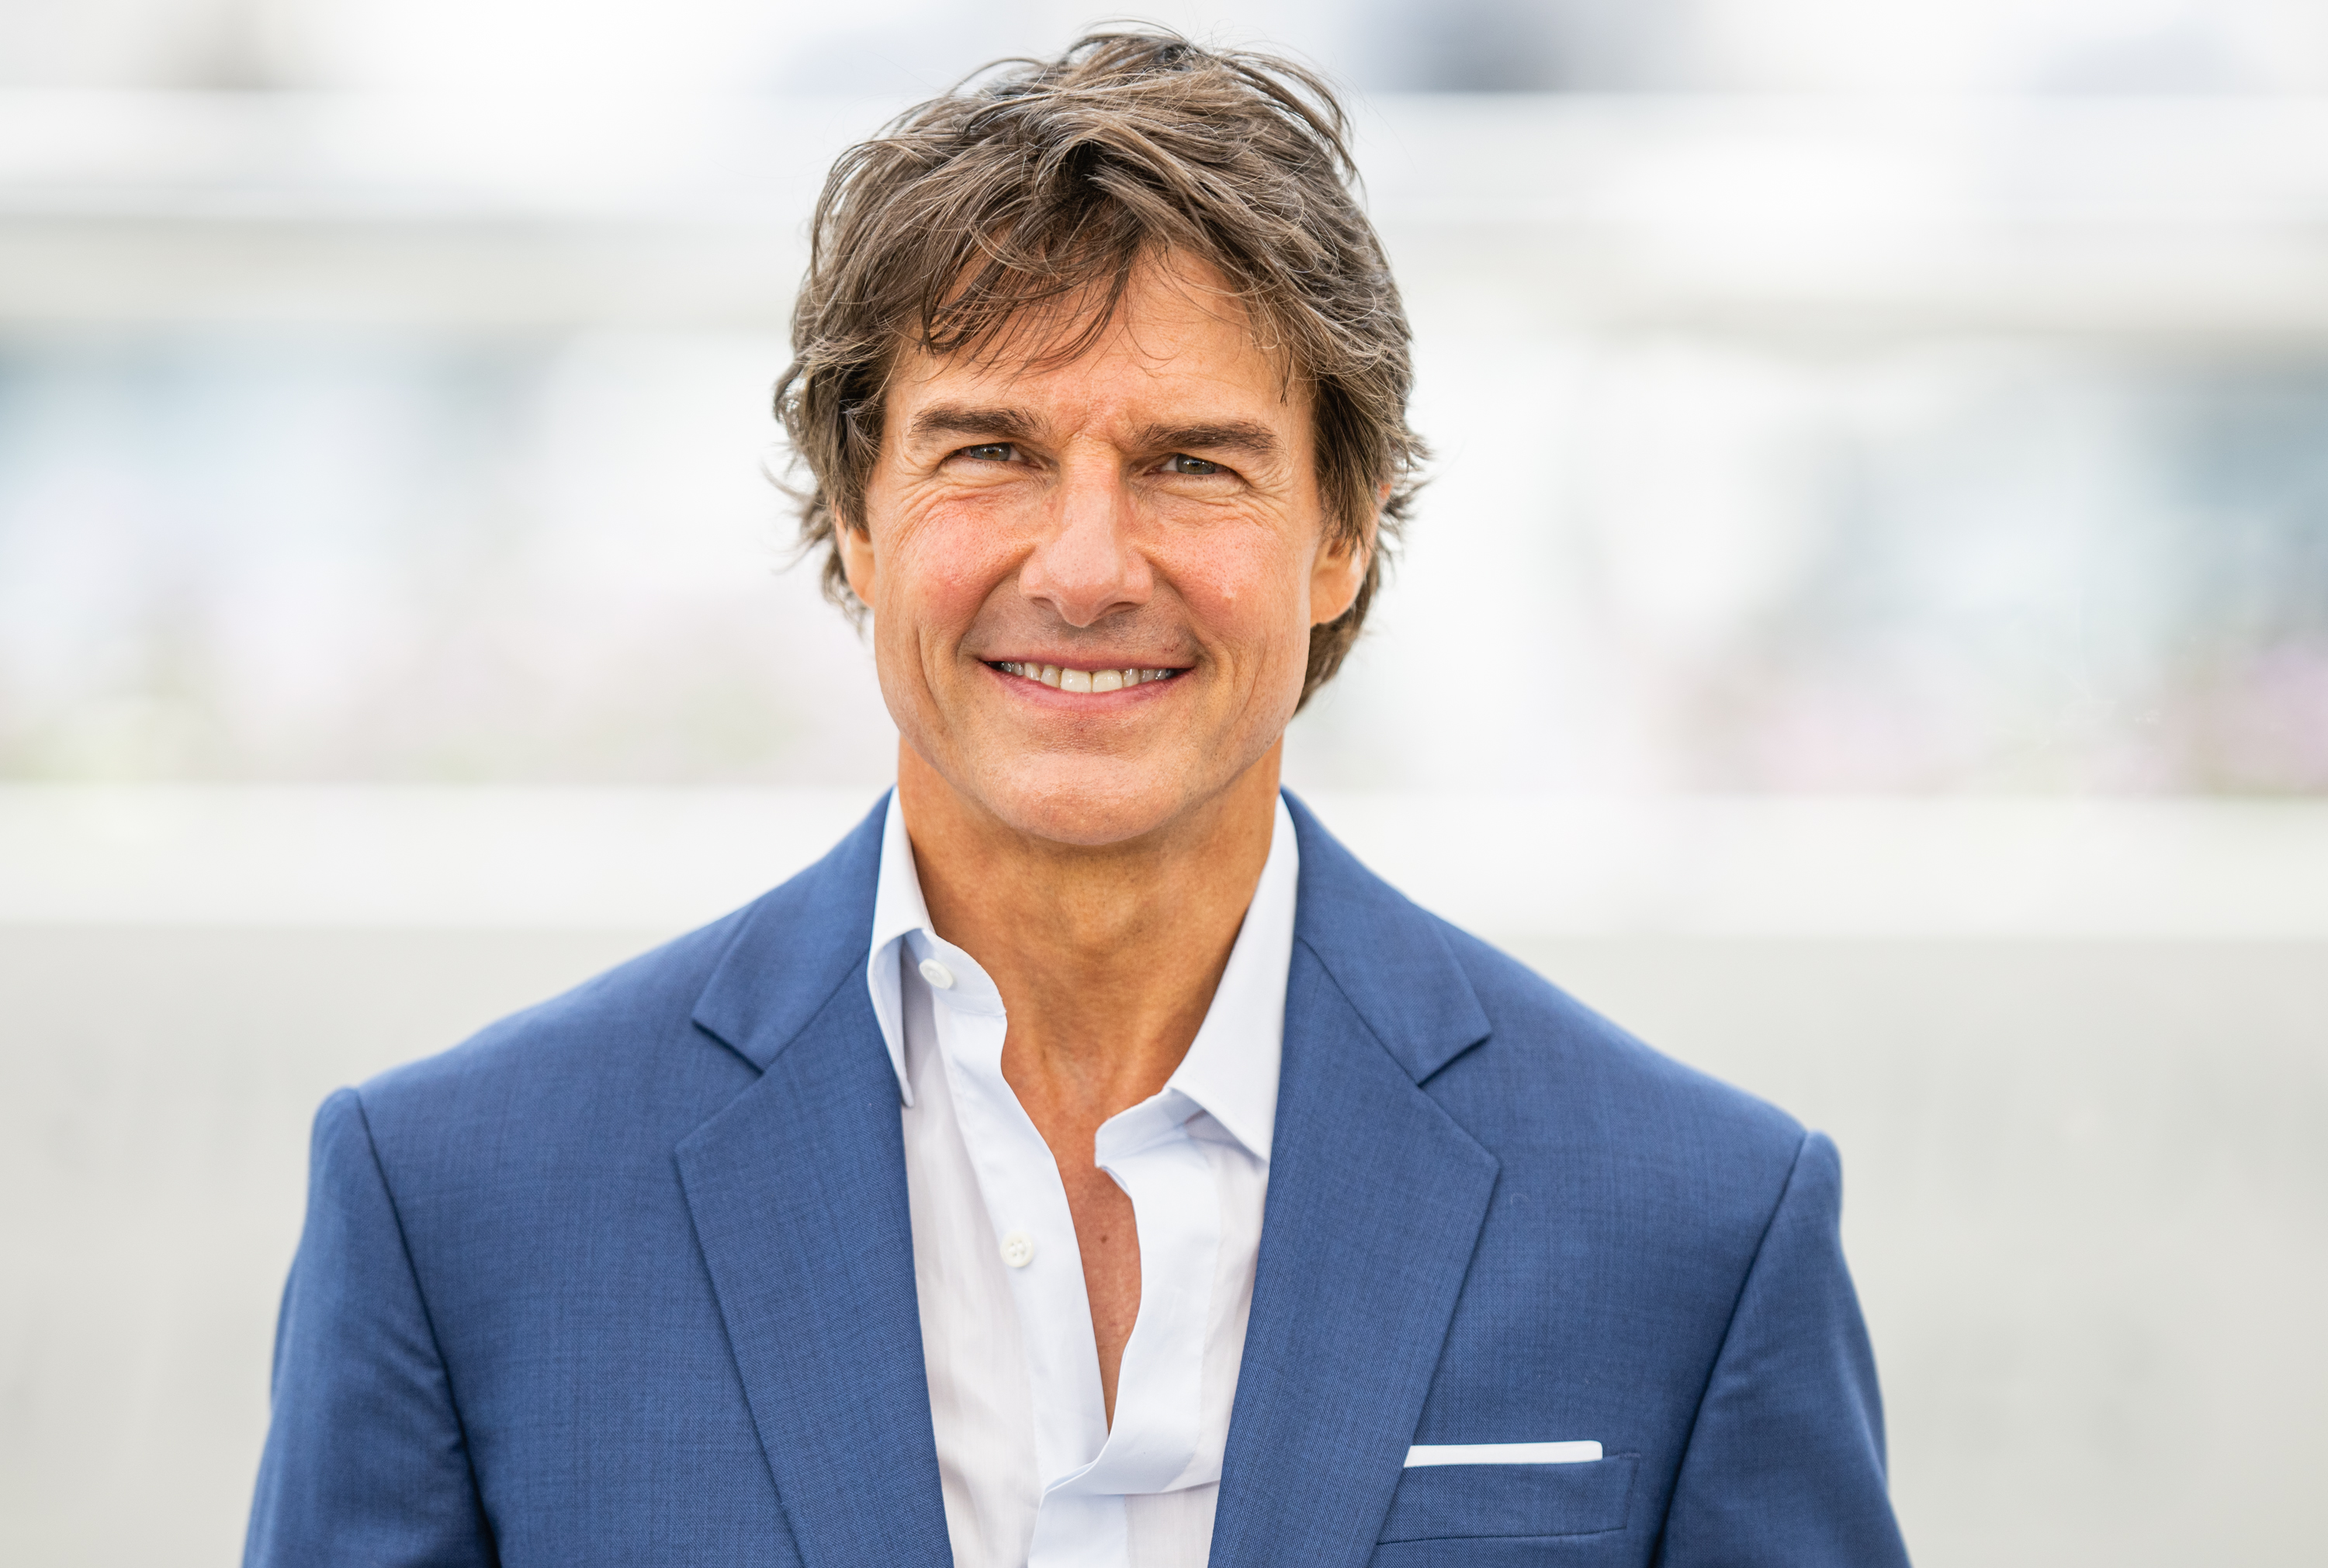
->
889, 261, 1308, 435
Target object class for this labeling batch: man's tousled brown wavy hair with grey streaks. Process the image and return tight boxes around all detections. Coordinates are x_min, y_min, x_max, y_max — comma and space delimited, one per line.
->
775, 33, 1427, 703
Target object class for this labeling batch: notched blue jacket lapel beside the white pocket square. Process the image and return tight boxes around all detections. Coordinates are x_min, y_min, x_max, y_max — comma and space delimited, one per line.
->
1211, 798, 1497, 1568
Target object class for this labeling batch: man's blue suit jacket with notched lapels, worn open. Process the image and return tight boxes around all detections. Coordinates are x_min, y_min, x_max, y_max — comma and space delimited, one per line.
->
244, 805, 1907, 1568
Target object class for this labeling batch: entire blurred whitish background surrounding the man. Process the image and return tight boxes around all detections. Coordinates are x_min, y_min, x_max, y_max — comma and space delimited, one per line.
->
0, 0, 2328, 1566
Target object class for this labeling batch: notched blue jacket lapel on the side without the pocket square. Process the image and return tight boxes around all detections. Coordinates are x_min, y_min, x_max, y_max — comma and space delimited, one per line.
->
677, 807, 952, 1568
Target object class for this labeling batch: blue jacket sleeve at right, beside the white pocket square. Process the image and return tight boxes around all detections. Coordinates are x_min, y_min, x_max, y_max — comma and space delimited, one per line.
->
1658, 1133, 1907, 1568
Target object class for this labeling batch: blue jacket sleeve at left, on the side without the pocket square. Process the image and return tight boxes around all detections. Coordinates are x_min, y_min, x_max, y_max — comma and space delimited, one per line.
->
242, 1089, 496, 1568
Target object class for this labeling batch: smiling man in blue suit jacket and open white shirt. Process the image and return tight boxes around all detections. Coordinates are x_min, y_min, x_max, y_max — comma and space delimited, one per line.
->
249, 35, 1904, 1568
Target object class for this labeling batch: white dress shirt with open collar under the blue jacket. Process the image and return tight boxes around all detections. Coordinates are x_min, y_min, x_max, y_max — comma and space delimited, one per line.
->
866, 793, 1299, 1568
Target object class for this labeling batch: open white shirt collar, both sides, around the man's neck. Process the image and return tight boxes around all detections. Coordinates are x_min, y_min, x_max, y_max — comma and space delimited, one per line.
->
866, 791, 1301, 1161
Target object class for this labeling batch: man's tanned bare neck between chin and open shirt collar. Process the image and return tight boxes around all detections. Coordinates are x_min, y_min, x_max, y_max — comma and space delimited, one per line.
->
896, 742, 1283, 1123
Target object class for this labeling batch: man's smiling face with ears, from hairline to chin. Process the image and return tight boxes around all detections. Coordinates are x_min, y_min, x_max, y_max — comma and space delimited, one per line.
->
840, 254, 1364, 844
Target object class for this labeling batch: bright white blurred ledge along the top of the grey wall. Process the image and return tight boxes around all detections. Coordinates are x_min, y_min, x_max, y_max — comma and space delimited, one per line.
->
0, 784, 2328, 942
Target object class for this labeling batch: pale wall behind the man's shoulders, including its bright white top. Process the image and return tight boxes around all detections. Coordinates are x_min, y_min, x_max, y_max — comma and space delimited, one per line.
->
0, 788, 2328, 1568
